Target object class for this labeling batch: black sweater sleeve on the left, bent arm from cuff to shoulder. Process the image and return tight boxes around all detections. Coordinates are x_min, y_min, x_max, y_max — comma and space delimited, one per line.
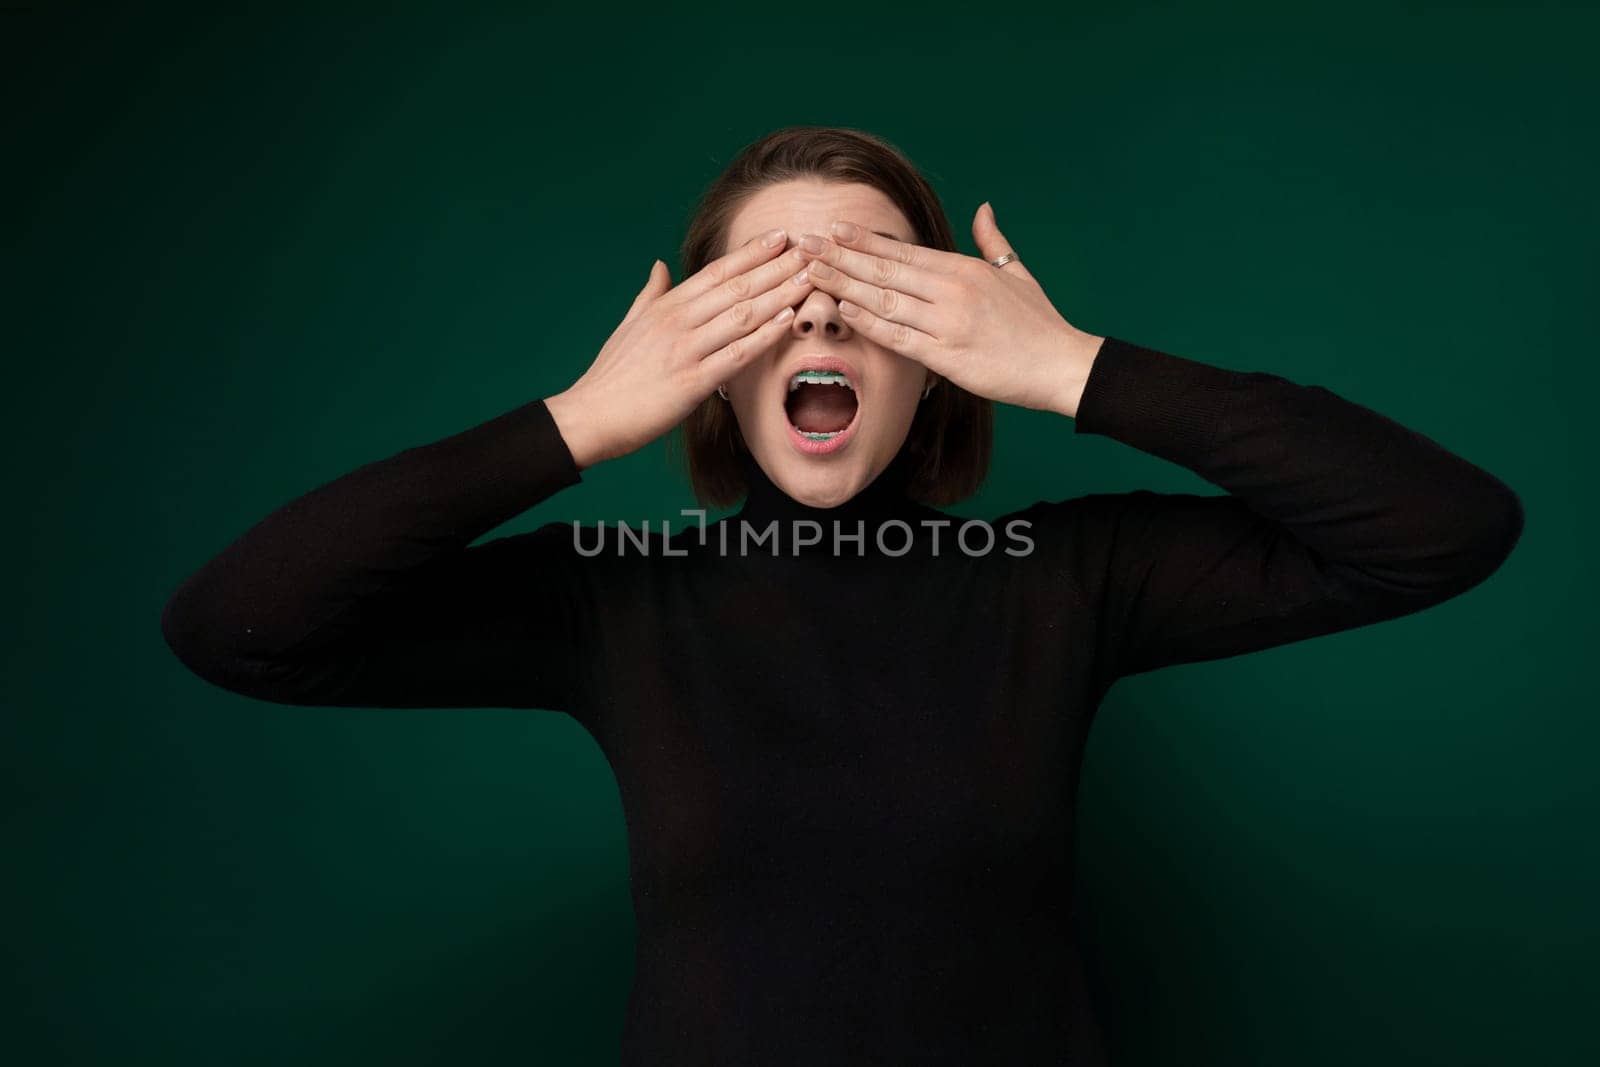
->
162, 400, 589, 712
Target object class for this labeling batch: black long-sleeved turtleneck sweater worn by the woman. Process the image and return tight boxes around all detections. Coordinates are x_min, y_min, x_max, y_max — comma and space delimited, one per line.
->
162, 338, 1523, 1065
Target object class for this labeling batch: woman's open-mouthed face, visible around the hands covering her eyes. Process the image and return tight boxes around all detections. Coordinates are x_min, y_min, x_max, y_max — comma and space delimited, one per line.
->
726, 179, 936, 507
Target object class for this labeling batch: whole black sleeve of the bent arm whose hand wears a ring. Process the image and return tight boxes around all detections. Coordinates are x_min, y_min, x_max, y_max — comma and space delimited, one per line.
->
1040, 338, 1523, 686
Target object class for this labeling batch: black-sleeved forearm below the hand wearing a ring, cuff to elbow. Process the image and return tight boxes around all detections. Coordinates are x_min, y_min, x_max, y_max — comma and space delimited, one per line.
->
1075, 339, 1522, 598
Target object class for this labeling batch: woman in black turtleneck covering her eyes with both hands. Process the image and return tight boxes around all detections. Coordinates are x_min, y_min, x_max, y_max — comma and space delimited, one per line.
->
162, 126, 1522, 1064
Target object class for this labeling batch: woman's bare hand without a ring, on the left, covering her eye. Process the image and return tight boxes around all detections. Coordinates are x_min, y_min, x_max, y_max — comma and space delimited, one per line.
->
546, 230, 816, 469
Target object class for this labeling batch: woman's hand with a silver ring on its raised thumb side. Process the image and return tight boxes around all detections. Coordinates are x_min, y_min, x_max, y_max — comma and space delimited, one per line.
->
796, 203, 1104, 418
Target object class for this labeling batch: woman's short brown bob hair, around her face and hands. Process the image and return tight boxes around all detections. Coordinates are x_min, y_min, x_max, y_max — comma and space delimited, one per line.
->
678, 126, 994, 507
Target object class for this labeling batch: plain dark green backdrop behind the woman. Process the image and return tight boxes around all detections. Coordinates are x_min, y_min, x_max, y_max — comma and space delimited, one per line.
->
0, 3, 1600, 1065
